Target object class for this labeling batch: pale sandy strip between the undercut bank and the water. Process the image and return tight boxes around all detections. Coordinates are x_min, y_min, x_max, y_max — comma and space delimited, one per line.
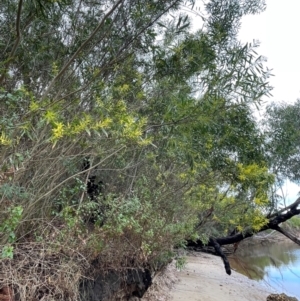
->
169, 253, 274, 301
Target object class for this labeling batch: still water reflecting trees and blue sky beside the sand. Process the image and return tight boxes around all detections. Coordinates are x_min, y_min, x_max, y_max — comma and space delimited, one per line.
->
229, 242, 300, 300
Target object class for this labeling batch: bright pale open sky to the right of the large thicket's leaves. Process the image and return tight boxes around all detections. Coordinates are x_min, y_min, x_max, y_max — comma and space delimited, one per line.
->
239, 0, 300, 203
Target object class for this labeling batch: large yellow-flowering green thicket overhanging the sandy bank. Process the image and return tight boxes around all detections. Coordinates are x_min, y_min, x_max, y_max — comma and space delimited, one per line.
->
0, 0, 282, 278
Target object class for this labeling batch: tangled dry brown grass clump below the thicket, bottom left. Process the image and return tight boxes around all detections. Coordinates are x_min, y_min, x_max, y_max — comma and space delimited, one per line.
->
0, 242, 88, 301
